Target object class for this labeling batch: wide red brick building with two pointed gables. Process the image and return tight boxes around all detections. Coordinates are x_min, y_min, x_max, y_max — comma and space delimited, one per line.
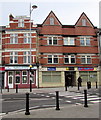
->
38, 11, 99, 87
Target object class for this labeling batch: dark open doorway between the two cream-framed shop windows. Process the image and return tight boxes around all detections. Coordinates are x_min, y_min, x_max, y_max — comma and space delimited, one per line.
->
65, 71, 76, 87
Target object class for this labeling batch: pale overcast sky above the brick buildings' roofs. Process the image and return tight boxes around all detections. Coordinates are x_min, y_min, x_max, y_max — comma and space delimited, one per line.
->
0, 0, 101, 27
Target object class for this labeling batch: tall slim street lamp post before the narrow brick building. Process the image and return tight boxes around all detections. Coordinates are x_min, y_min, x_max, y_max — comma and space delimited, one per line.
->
29, 3, 37, 89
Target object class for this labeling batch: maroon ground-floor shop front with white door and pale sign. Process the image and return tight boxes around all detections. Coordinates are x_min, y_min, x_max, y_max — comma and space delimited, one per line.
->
5, 66, 37, 88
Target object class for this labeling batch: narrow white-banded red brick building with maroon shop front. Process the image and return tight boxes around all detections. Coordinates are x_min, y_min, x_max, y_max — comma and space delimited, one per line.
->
2, 15, 37, 88
